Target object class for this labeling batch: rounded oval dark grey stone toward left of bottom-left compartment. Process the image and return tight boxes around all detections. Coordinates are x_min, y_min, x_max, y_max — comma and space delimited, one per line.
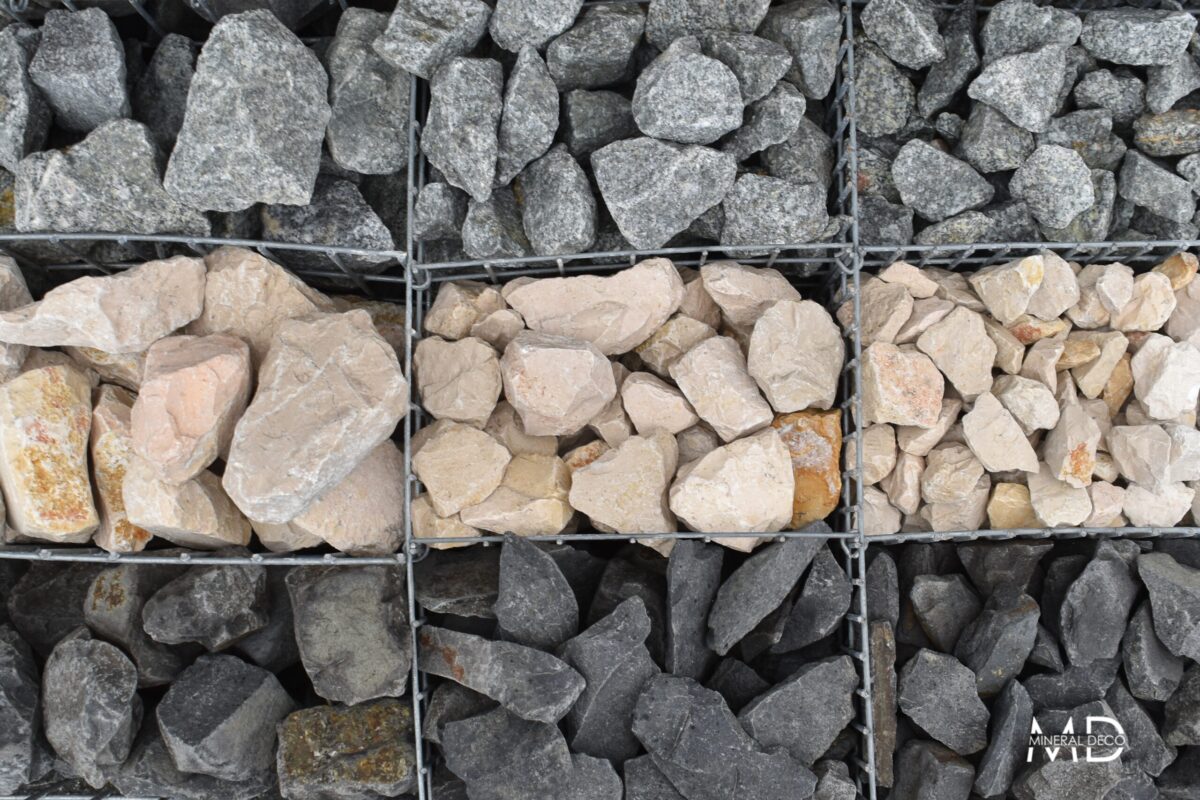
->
42, 638, 142, 789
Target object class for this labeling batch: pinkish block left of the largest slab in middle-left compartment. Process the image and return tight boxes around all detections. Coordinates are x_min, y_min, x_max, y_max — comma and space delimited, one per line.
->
131, 333, 251, 483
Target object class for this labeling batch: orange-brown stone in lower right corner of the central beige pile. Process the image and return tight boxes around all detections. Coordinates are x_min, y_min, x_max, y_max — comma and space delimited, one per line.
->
772, 411, 841, 530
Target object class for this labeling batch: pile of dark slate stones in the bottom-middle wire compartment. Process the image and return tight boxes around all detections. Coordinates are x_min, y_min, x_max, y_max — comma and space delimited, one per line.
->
414, 532, 859, 800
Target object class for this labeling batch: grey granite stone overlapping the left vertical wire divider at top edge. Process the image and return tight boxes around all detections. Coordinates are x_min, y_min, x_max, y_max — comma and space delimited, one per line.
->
374, 0, 492, 80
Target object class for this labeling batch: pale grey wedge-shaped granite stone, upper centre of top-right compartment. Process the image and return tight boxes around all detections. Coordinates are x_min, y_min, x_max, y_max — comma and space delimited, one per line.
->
967, 44, 1067, 133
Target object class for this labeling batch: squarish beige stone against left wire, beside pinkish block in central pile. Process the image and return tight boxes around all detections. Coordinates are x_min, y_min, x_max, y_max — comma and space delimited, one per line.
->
413, 336, 503, 428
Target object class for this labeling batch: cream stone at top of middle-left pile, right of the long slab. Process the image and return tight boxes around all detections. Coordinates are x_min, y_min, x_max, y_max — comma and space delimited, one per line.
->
186, 247, 334, 365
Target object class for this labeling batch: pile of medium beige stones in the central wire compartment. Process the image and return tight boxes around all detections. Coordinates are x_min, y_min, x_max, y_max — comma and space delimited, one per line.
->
413, 258, 845, 554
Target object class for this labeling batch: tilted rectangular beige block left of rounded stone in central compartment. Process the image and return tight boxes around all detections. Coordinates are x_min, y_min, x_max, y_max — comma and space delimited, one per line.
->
671, 336, 774, 441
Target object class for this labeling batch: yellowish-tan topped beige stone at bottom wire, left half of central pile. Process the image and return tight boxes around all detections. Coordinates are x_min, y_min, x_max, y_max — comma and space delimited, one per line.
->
458, 453, 573, 536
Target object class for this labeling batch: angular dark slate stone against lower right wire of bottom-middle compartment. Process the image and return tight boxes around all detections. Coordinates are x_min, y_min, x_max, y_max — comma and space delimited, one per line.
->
738, 656, 858, 766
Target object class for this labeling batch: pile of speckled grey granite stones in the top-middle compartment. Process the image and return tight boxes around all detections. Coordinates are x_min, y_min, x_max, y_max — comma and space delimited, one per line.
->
412, 0, 844, 260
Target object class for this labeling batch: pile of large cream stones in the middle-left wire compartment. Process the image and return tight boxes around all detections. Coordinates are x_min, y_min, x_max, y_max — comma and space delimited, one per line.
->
0, 247, 408, 555
